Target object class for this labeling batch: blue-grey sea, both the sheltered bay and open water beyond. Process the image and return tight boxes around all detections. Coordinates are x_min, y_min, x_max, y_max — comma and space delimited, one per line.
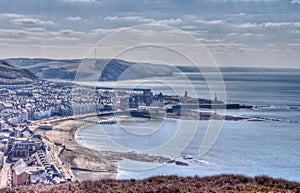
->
76, 67, 300, 182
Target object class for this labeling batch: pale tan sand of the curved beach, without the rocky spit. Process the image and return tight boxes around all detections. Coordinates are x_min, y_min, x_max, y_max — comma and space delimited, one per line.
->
35, 118, 117, 181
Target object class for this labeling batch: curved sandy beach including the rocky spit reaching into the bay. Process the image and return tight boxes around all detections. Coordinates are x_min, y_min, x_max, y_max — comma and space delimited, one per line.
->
31, 116, 170, 181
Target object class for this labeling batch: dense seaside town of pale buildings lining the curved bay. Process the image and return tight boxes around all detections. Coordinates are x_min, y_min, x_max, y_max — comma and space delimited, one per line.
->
0, 80, 243, 188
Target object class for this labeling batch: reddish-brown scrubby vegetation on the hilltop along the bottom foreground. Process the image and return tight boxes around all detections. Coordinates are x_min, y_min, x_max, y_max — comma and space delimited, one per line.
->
1, 175, 300, 193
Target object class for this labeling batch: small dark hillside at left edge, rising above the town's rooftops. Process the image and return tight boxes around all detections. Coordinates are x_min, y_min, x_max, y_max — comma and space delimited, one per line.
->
0, 61, 37, 84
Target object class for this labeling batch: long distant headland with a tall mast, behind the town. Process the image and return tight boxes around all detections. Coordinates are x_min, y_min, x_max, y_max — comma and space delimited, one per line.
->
5, 58, 174, 81
